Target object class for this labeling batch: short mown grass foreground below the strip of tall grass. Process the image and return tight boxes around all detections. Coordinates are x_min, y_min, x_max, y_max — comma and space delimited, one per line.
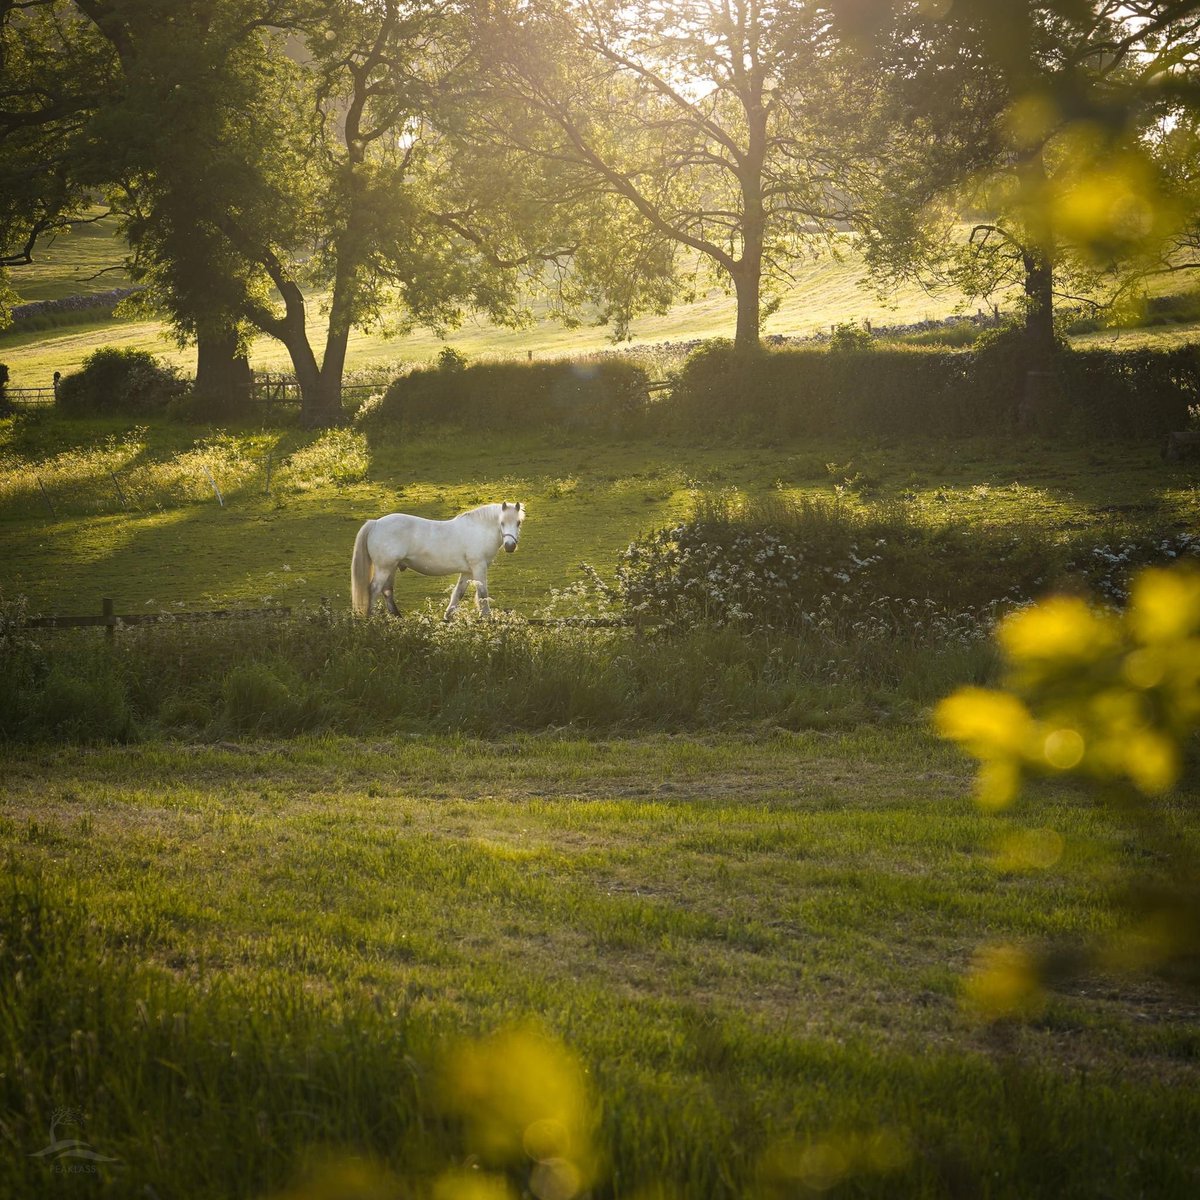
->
7, 728, 1200, 1198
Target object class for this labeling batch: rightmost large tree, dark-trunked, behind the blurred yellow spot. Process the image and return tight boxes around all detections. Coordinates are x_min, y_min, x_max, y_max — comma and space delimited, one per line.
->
840, 0, 1200, 369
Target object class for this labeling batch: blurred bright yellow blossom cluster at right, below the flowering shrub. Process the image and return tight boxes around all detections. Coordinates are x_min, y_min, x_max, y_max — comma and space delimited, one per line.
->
935, 565, 1200, 998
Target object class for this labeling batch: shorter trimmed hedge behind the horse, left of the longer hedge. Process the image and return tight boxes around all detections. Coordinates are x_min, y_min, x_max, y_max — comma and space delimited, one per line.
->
364, 354, 649, 433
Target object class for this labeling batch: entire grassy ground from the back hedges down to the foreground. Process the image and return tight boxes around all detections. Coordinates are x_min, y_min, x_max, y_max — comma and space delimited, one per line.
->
0, 391, 1200, 1198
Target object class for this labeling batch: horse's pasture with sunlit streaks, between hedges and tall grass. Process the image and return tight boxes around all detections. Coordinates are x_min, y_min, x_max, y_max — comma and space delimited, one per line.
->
0, 413, 1200, 616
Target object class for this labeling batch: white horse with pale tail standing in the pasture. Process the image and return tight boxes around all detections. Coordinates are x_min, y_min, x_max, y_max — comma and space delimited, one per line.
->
350, 500, 526, 620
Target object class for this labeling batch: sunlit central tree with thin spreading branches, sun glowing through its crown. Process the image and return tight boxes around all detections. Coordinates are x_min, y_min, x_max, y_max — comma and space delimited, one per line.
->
463, 0, 897, 348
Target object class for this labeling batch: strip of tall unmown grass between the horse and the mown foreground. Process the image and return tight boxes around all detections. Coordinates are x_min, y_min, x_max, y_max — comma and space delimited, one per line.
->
0, 612, 991, 740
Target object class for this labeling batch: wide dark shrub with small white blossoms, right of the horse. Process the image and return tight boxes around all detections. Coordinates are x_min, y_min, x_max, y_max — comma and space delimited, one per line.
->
606, 497, 1200, 640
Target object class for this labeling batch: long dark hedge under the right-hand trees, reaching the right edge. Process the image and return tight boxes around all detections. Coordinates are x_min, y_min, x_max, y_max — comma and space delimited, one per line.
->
658, 336, 1200, 438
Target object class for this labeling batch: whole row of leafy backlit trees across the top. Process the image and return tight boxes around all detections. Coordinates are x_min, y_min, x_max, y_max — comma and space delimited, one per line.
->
0, 0, 1200, 422
